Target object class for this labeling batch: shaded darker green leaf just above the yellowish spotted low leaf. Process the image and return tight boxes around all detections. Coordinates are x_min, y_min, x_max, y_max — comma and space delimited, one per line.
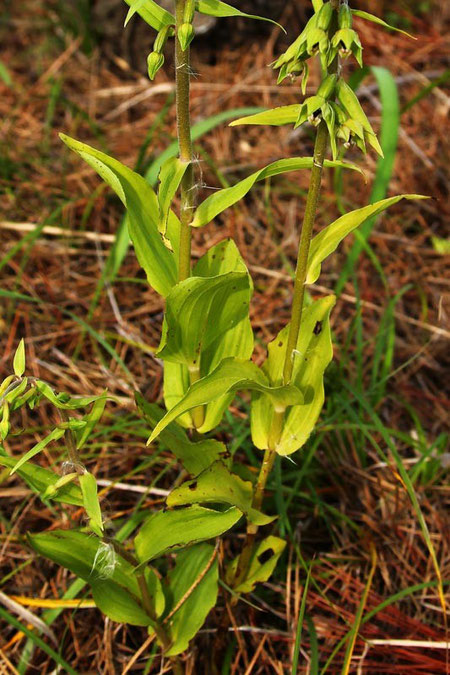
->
135, 392, 229, 476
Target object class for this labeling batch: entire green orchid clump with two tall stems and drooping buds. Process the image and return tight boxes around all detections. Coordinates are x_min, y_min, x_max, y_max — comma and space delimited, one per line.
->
0, 0, 420, 673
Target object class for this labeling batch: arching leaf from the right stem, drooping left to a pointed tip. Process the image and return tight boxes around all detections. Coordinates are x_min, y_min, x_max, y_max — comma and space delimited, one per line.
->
147, 358, 303, 443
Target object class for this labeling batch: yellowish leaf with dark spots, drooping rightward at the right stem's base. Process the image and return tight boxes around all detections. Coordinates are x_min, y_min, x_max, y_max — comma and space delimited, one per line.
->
167, 460, 274, 525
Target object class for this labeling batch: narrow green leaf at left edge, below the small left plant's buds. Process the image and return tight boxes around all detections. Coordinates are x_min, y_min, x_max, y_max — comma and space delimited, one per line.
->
0, 448, 83, 506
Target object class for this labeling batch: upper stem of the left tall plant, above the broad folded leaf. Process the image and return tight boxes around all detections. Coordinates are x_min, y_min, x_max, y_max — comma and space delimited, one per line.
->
175, 0, 195, 281
